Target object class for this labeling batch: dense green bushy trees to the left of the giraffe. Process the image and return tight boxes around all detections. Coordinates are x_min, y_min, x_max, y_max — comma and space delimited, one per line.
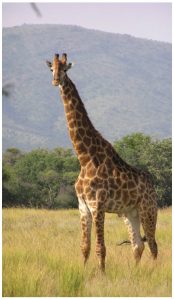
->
3, 148, 79, 208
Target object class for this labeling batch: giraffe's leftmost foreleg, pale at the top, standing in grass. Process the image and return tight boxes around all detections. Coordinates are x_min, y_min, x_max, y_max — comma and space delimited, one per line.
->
78, 198, 92, 265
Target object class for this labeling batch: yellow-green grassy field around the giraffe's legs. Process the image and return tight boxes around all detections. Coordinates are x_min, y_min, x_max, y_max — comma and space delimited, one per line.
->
2, 208, 172, 297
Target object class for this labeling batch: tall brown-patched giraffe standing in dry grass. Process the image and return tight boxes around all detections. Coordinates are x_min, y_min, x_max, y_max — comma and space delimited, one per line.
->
47, 53, 158, 272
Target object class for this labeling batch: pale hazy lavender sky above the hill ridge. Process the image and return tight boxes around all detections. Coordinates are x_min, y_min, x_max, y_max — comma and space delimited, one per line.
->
2, 2, 172, 43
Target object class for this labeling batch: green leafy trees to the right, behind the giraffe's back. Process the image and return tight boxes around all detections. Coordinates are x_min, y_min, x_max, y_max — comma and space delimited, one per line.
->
114, 133, 172, 207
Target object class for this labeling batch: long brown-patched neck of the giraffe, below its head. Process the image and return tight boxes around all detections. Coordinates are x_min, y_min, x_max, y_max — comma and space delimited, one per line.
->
60, 76, 100, 165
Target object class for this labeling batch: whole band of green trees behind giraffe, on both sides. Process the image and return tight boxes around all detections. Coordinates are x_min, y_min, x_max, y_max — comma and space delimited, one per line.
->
2, 133, 172, 209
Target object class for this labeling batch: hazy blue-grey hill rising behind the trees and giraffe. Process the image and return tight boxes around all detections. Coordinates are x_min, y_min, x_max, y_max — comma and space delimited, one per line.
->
2, 25, 172, 150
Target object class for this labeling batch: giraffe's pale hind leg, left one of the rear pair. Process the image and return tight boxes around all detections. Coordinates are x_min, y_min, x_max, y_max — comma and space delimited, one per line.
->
124, 209, 144, 263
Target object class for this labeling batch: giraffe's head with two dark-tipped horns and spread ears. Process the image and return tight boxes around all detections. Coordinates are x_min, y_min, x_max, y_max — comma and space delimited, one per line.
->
46, 53, 72, 86
